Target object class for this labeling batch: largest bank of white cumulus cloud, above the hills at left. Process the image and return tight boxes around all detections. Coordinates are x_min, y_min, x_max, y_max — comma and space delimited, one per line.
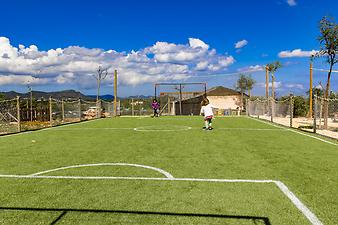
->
0, 37, 235, 88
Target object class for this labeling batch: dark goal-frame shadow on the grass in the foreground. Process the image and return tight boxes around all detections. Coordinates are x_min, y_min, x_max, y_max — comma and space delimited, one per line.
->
0, 207, 271, 225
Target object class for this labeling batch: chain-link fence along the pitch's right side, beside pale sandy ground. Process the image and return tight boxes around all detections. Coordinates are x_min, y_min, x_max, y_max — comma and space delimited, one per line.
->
247, 96, 338, 139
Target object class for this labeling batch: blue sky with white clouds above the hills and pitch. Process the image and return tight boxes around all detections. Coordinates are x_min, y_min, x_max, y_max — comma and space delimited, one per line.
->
0, 0, 338, 96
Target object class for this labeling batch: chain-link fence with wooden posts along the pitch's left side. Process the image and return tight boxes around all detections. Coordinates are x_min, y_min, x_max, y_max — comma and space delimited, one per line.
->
0, 97, 121, 135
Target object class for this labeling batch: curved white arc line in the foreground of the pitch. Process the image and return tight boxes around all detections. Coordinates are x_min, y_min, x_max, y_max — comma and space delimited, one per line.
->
28, 163, 174, 179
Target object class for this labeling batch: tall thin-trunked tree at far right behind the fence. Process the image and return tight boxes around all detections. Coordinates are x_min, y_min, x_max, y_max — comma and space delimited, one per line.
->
317, 16, 338, 129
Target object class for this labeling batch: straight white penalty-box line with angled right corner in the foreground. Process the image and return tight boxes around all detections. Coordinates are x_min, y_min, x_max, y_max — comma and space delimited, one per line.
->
0, 175, 323, 225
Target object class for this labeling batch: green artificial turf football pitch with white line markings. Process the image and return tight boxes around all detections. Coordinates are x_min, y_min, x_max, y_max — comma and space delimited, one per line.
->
0, 116, 338, 225
